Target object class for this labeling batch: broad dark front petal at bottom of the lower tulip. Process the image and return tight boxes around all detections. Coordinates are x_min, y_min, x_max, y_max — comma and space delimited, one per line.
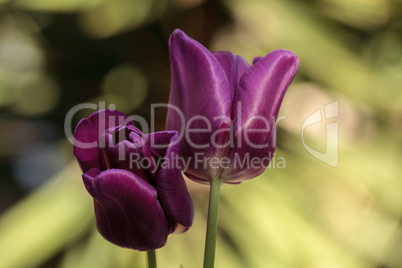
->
83, 169, 170, 251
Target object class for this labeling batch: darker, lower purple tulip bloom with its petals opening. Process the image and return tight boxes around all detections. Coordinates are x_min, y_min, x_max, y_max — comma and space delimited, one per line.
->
74, 110, 193, 251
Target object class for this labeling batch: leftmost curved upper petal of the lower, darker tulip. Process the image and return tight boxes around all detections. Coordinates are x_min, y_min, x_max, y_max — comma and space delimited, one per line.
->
73, 110, 133, 173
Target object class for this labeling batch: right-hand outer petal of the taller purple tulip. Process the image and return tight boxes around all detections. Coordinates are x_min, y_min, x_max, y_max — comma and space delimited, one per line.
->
221, 50, 298, 182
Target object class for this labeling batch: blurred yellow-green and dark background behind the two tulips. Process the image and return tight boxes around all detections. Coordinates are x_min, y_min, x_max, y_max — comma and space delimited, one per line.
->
0, 0, 402, 268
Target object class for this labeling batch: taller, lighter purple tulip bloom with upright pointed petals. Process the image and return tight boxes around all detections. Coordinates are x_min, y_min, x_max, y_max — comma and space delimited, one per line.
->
166, 30, 298, 183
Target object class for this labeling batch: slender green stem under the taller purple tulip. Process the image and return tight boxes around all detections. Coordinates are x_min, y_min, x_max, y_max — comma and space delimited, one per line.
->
204, 178, 222, 268
